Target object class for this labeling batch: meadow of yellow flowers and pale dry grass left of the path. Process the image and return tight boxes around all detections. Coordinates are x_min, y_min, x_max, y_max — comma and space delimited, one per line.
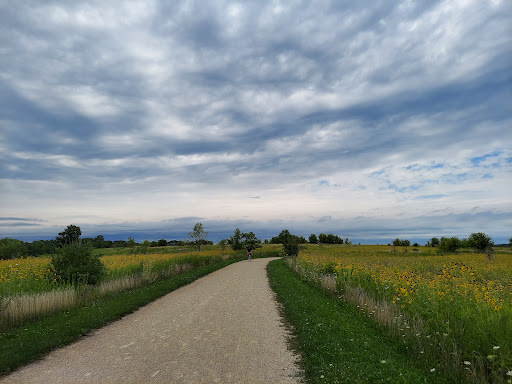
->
0, 246, 279, 331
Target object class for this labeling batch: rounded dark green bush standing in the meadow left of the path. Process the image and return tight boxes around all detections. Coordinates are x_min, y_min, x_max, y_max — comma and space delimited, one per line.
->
50, 242, 106, 284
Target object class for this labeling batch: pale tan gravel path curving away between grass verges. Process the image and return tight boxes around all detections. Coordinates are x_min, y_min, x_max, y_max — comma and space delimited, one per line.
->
0, 259, 300, 384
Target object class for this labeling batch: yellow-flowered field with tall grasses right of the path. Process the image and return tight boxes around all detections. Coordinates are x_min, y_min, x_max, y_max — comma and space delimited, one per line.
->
289, 245, 512, 383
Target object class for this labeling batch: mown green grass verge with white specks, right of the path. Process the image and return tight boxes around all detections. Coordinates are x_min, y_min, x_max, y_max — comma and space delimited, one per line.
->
267, 260, 446, 383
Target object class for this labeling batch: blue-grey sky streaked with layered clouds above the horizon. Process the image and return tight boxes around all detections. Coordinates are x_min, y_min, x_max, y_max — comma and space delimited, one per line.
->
0, 0, 512, 243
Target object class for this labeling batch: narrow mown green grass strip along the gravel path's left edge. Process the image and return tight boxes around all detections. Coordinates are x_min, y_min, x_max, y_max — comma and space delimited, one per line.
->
0, 258, 241, 376
